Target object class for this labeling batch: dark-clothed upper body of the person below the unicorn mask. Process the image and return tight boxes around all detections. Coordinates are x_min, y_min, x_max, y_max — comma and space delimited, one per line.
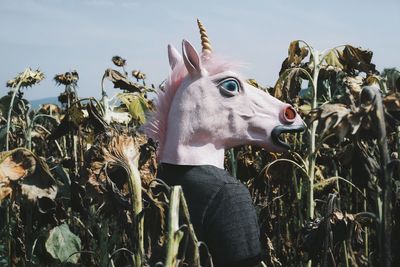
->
157, 163, 261, 267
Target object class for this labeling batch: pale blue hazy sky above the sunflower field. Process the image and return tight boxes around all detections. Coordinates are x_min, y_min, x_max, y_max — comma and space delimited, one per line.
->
0, 0, 400, 100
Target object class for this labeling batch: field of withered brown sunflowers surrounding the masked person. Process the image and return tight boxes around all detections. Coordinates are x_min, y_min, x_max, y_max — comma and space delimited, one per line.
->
0, 47, 400, 266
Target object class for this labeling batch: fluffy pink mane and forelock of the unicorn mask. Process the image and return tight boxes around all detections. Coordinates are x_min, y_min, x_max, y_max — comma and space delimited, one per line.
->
143, 54, 237, 158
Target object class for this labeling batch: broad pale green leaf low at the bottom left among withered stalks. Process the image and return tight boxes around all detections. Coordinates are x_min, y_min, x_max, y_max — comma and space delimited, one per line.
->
45, 224, 81, 264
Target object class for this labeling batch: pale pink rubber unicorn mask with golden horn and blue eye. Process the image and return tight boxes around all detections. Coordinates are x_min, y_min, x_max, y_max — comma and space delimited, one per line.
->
145, 21, 305, 168
